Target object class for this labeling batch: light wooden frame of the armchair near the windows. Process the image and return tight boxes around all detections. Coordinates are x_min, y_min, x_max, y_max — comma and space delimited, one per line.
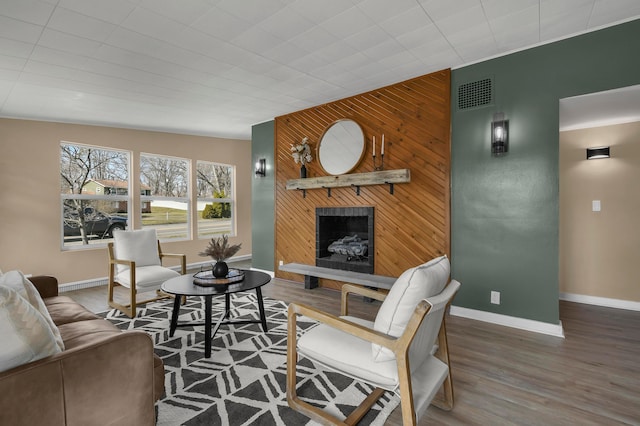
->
107, 241, 187, 318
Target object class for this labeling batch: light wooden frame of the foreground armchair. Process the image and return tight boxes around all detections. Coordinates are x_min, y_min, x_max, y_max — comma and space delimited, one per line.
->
287, 284, 454, 425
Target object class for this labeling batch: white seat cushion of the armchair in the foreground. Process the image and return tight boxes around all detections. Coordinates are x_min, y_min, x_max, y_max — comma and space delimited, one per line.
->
297, 316, 398, 390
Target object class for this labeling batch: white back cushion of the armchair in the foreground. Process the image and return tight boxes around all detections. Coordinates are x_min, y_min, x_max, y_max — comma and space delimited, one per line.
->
372, 256, 450, 362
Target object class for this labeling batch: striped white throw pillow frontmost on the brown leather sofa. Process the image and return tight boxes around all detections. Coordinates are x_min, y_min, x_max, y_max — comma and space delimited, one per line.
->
0, 287, 61, 371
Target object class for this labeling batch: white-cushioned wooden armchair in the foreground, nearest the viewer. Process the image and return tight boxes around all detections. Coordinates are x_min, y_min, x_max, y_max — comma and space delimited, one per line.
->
287, 256, 460, 425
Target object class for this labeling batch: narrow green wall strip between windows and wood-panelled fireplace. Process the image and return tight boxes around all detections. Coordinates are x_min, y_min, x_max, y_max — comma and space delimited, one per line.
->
251, 121, 275, 271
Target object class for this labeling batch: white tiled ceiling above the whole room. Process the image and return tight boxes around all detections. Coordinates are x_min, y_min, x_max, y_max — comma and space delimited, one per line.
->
0, 0, 640, 139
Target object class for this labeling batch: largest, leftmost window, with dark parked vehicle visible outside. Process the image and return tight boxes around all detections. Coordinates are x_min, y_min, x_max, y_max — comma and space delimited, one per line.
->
60, 142, 130, 249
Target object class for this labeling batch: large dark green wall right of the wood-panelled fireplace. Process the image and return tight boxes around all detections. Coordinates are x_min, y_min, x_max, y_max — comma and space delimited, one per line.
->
451, 20, 640, 324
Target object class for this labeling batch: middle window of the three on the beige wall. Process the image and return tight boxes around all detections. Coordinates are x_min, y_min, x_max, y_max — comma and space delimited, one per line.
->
140, 154, 190, 240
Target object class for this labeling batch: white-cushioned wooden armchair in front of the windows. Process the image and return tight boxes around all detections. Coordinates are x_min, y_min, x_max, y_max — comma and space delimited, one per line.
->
107, 229, 187, 318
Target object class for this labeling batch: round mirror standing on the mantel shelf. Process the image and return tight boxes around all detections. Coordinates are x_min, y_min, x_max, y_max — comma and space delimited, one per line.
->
318, 120, 365, 175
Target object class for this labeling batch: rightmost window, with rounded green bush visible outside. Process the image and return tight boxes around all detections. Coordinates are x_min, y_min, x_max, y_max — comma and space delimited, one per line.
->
196, 161, 235, 238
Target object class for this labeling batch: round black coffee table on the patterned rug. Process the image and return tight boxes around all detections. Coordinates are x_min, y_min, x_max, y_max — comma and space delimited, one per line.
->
162, 270, 271, 358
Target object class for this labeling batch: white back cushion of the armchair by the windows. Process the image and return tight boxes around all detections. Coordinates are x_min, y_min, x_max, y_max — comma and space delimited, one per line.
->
113, 228, 161, 273
